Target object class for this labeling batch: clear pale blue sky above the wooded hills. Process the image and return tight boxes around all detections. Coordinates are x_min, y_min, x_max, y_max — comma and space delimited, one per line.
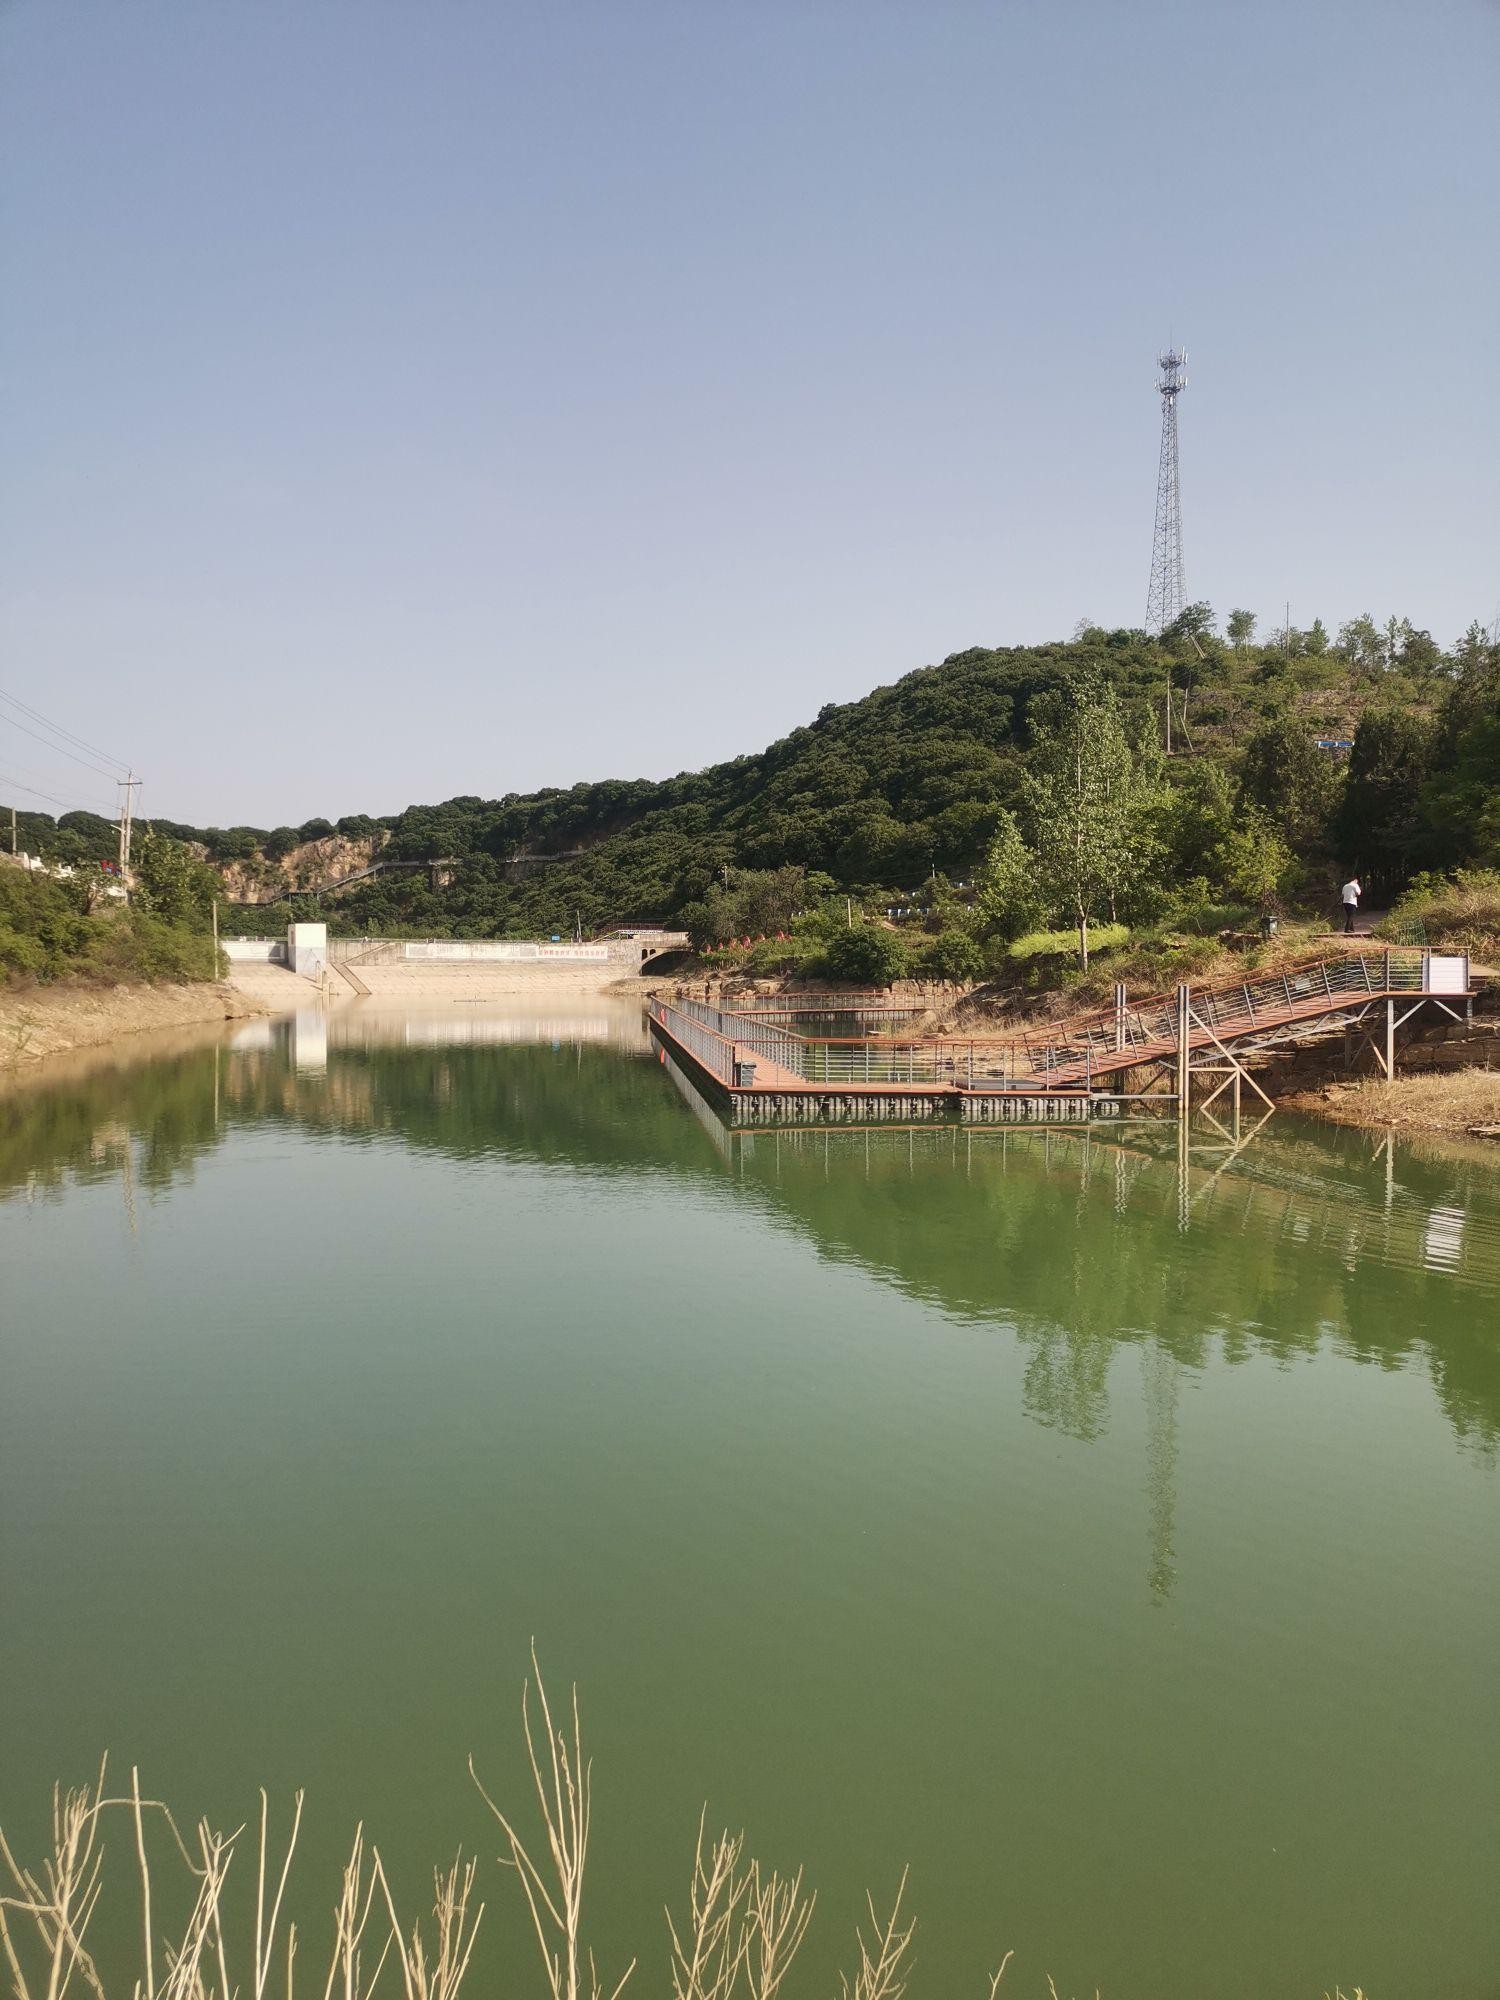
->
0, 0, 1500, 824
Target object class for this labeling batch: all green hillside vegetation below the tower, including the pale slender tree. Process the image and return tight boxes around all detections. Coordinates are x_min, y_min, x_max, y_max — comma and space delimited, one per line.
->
5, 604, 1500, 982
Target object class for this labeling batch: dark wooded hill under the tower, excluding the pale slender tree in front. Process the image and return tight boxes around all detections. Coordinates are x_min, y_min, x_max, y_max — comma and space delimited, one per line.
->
20, 606, 1500, 936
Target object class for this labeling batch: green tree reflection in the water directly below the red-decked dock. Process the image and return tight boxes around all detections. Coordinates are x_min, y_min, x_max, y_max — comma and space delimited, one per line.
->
746, 1120, 1500, 1448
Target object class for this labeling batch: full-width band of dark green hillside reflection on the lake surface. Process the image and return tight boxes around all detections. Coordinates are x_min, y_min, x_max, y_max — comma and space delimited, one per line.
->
11, 1044, 1500, 1472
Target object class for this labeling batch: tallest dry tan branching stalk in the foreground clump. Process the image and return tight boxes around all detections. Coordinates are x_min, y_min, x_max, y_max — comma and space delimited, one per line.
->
468, 1644, 636, 2000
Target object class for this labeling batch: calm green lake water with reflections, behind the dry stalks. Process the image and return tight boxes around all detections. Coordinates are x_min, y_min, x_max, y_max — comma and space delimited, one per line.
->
0, 1000, 1500, 2000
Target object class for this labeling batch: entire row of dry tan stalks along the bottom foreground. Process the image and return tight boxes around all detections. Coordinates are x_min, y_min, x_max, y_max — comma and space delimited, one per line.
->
0, 1652, 1364, 2000
